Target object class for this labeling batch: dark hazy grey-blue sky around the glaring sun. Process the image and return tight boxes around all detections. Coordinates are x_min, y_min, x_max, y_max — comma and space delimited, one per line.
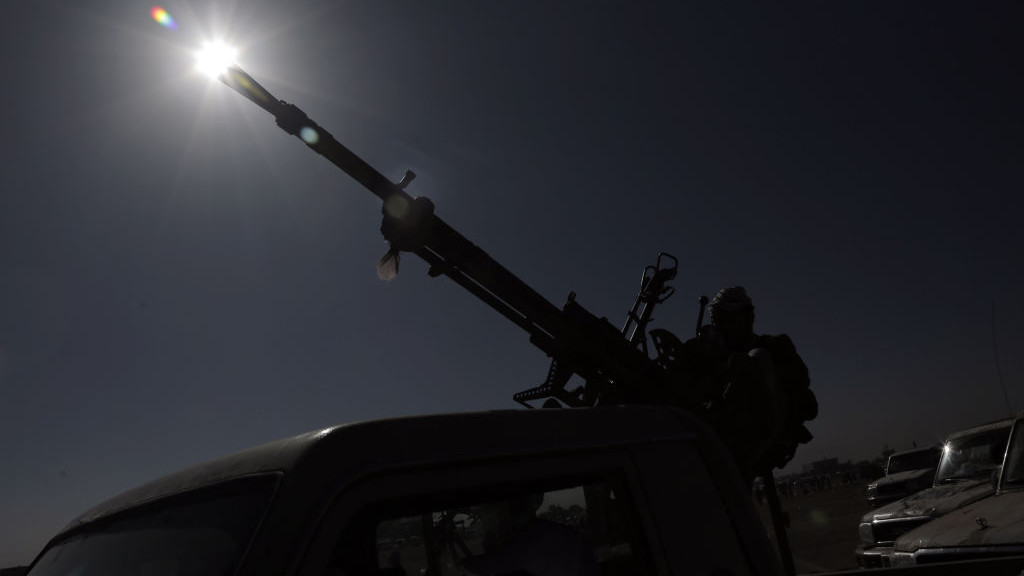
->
0, 0, 1024, 567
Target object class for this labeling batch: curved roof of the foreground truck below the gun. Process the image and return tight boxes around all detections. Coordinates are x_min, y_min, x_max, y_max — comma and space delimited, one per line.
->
57, 406, 729, 538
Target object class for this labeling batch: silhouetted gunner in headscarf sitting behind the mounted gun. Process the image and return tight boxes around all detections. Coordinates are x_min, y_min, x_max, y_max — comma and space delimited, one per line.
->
670, 286, 818, 482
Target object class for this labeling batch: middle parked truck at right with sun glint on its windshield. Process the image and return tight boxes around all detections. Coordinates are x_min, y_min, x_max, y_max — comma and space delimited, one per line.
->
854, 418, 1013, 568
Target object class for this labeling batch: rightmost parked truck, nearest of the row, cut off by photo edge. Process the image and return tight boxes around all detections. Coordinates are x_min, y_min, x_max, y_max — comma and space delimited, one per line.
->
893, 415, 1024, 566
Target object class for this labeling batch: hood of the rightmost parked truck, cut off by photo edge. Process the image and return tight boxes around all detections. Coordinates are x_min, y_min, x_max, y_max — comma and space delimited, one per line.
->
895, 491, 1024, 552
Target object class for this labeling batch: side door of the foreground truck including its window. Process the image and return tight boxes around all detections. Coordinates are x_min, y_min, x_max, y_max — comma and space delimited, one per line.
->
299, 448, 669, 576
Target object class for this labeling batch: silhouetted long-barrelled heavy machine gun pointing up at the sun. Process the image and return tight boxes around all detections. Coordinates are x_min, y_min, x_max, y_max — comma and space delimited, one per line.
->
220, 66, 678, 408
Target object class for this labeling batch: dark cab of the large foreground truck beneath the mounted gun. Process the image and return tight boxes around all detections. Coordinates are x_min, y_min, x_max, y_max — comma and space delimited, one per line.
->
22, 407, 780, 576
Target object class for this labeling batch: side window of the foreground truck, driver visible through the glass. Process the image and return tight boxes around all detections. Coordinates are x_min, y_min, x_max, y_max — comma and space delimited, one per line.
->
338, 483, 649, 576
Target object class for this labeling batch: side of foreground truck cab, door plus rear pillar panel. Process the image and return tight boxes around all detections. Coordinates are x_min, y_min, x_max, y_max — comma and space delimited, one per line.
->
290, 436, 778, 576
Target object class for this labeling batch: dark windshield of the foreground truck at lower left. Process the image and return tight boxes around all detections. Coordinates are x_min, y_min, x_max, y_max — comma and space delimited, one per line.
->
29, 477, 276, 576
